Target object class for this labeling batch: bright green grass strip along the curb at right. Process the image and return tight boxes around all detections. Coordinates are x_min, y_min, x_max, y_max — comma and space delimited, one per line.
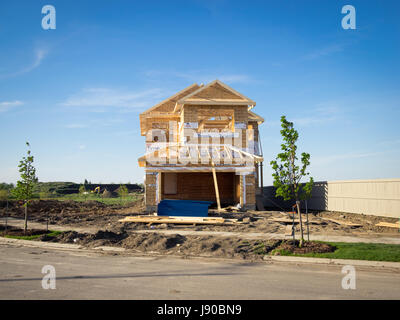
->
271, 241, 400, 262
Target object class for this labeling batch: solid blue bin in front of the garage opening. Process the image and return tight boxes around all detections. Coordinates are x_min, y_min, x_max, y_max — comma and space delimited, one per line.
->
157, 200, 213, 217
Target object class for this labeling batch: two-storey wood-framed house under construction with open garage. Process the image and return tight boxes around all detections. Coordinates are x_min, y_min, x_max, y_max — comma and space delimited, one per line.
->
138, 80, 264, 212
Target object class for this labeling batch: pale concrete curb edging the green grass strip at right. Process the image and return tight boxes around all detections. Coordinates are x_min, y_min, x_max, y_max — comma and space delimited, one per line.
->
263, 256, 400, 269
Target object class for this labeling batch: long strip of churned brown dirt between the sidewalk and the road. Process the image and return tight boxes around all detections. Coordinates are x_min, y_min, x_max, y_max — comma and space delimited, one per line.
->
50, 231, 315, 260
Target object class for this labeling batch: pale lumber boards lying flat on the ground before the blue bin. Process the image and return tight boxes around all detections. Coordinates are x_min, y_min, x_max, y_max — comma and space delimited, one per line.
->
118, 216, 240, 225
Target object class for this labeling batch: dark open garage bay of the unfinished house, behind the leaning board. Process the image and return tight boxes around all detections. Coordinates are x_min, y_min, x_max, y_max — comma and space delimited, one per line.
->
161, 172, 240, 206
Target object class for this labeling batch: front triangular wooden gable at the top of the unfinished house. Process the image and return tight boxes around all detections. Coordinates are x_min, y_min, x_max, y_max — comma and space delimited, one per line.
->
177, 80, 256, 106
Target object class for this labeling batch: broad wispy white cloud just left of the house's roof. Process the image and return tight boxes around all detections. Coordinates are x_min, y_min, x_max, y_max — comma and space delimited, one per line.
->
60, 88, 165, 112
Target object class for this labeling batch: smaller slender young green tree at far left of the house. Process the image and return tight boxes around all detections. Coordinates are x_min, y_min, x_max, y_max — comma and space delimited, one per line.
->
12, 142, 38, 234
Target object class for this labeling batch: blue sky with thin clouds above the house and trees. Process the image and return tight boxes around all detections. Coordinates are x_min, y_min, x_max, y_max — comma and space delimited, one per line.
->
0, 0, 400, 185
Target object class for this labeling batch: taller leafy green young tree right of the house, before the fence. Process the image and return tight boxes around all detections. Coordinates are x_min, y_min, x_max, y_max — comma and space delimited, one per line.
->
270, 116, 314, 246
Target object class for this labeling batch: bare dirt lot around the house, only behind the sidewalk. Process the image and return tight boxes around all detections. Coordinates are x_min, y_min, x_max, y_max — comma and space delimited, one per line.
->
0, 200, 400, 237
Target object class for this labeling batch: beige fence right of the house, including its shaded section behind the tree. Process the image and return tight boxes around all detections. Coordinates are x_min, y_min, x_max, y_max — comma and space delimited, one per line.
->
264, 179, 400, 218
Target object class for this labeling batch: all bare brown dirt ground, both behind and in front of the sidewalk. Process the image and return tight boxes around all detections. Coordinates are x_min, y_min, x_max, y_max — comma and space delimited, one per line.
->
0, 200, 400, 260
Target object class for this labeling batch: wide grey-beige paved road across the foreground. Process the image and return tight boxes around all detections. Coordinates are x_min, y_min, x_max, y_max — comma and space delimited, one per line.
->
0, 244, 400, 300
